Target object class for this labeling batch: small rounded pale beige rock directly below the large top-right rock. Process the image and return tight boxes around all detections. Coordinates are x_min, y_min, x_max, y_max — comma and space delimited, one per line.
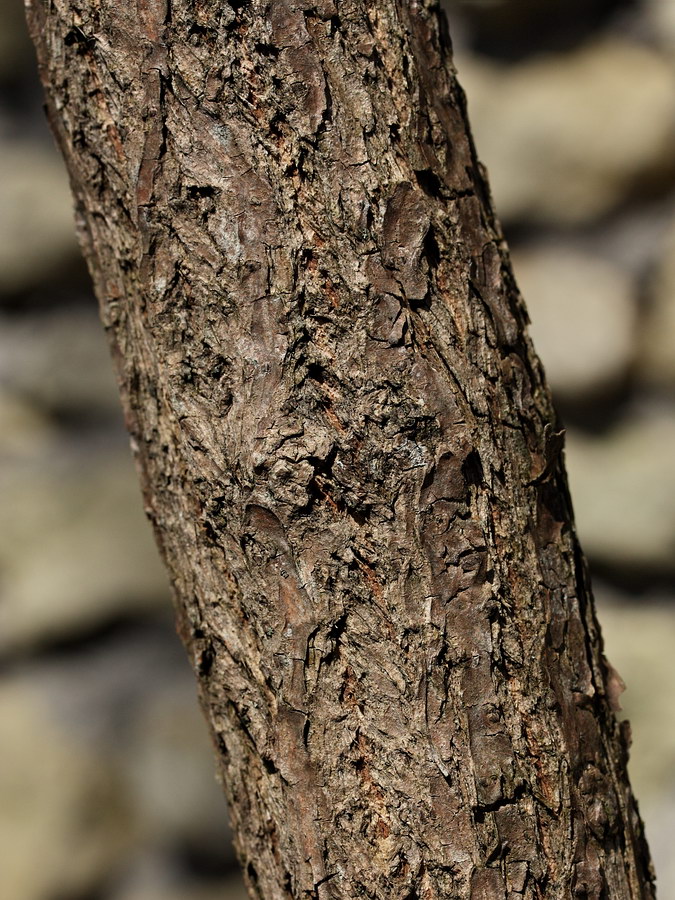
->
513, 244, 636, 400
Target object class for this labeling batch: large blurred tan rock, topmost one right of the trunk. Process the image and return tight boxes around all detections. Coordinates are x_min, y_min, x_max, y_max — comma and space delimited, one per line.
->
458, 37, 675, 225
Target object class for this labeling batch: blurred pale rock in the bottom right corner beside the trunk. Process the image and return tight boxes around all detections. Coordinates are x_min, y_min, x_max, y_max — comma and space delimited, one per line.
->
596, 588, 675, 900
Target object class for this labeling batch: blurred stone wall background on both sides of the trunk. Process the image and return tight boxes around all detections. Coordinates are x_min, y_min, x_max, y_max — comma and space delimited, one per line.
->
0, 0, 675, 900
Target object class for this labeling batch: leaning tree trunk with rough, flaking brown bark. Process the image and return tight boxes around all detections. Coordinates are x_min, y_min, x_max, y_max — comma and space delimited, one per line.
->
29, 0, 653, 900
